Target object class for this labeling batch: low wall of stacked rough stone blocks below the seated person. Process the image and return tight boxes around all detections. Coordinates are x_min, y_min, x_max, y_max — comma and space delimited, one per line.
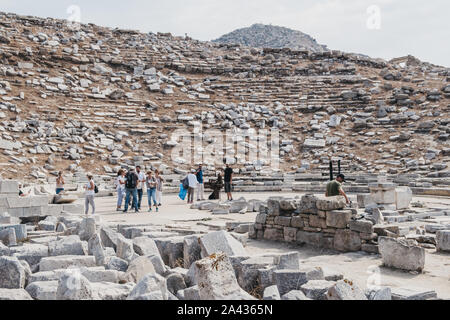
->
249, 194, 378, 253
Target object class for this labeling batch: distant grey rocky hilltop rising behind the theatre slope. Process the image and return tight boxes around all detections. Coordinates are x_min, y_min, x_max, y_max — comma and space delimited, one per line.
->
213, 23, 328, 52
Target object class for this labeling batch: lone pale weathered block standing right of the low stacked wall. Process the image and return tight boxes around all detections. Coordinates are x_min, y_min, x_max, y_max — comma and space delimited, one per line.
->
378, 237, 425, 272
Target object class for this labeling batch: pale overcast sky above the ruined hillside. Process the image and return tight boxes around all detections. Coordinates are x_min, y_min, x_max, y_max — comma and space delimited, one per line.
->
0, 0, 450, 67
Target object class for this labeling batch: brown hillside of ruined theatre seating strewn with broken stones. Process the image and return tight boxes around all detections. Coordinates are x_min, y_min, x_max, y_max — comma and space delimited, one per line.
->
0, 13, 450, 185
